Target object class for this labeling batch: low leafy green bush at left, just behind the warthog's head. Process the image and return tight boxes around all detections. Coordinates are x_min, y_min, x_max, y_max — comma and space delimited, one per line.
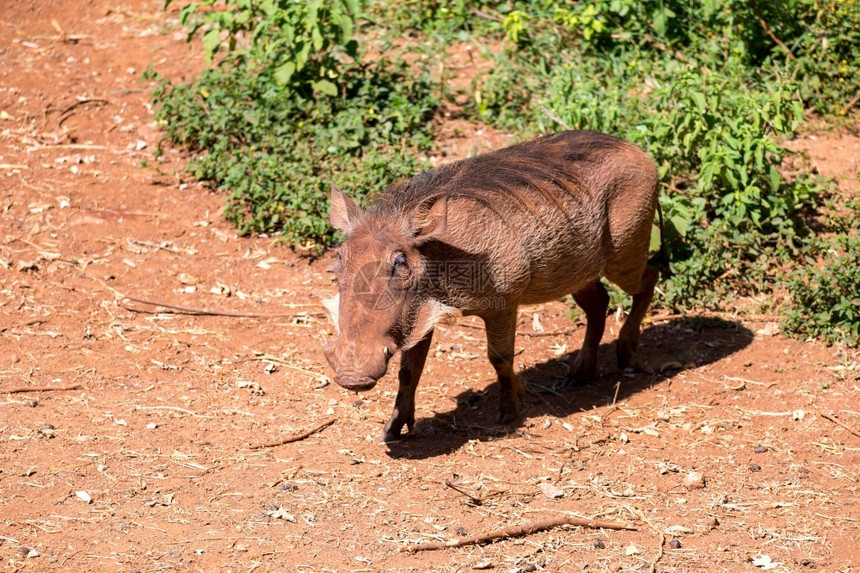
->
153, 0, 440, 246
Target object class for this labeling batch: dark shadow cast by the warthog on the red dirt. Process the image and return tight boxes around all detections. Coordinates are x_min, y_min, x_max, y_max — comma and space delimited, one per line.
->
388, 318, 753, 459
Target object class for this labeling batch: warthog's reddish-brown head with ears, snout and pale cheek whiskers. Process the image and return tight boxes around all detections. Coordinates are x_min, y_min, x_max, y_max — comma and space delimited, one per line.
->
323, 185, 452, 391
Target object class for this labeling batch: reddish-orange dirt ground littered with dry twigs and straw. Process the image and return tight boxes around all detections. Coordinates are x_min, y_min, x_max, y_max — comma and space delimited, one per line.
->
0, 0, 860, 572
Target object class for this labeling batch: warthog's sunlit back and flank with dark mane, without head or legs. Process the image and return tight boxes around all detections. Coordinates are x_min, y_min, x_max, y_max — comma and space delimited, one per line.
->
371, 131, 658, 303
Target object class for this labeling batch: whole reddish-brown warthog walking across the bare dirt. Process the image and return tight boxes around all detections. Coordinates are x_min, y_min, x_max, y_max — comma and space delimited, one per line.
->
324, 131, 659, 442
